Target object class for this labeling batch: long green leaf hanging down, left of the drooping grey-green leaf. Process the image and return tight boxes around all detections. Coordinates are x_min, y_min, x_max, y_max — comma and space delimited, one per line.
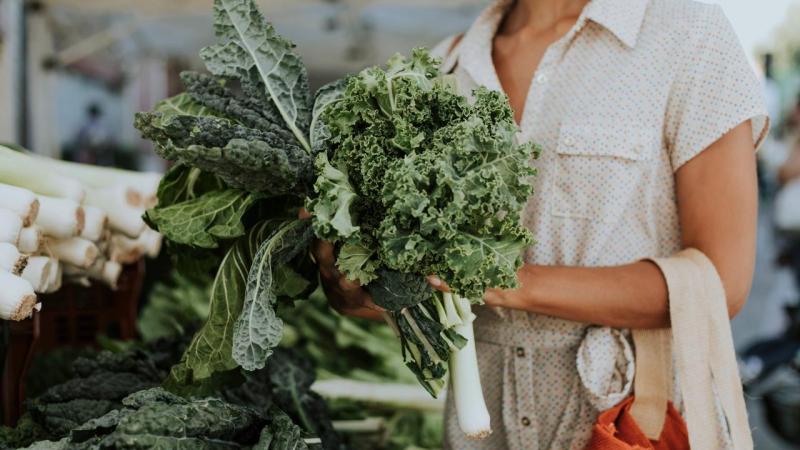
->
168, 220, 283, 387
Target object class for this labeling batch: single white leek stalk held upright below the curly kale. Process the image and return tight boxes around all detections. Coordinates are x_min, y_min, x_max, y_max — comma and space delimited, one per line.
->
444, 293, 492, 439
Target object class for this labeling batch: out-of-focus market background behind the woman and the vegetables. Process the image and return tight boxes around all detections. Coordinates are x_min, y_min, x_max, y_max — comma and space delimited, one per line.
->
0, 0, 800, 449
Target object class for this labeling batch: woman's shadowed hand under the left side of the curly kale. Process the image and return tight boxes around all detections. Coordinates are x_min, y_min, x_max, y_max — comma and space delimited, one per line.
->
311, 240, 383, 321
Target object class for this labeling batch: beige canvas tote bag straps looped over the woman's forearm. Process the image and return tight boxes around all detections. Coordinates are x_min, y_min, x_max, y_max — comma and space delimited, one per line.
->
631, 249, 753, 450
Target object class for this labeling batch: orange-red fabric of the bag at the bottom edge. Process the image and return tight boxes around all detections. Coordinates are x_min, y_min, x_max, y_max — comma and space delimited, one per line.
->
586, 397, 689, 450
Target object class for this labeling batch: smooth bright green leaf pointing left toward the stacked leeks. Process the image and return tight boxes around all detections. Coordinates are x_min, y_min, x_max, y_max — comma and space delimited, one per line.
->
146, 189, 258, 248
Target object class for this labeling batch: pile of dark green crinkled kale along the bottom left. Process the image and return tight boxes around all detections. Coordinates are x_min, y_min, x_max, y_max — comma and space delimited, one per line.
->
0, 336, 345, 450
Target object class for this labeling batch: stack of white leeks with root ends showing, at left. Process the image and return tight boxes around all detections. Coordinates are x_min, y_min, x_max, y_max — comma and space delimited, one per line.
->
0, 145, 161, 320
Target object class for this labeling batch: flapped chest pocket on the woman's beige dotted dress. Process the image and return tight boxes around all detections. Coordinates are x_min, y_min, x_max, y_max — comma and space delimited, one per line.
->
552, 125, 657, 222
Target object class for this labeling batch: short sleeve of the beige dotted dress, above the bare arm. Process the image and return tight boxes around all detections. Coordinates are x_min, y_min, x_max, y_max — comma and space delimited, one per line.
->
665, 6, 769, 171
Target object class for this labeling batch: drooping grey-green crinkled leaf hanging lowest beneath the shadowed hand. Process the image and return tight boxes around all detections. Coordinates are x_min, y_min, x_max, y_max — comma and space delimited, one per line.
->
233, 220, 313, 370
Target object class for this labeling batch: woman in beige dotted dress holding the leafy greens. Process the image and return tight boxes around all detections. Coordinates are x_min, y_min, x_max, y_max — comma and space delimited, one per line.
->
317, 0, 768, 450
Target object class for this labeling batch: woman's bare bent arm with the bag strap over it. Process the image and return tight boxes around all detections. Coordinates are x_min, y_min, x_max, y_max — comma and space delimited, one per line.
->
432, 121, 758, 328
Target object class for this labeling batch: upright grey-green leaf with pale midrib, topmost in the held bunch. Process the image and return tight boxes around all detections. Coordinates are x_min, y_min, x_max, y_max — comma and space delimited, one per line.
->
200, 0, 311, 153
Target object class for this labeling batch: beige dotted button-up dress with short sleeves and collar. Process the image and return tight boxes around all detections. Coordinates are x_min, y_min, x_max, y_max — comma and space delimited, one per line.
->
436, 0, 768, 450
